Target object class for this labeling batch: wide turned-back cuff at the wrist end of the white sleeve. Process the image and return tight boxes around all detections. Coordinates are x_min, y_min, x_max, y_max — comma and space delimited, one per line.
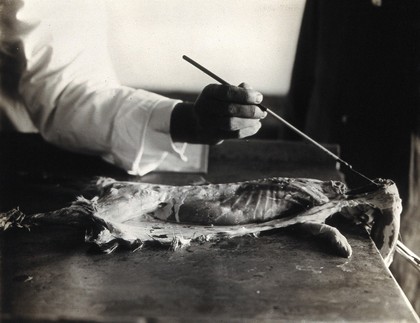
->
102, 87, 191, 176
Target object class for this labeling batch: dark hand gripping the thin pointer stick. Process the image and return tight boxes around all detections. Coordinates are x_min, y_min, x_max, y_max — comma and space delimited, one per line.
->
171, 83, 267, 144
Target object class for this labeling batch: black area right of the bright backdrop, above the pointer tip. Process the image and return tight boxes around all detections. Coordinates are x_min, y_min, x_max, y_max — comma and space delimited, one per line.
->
288, 0, 420, 195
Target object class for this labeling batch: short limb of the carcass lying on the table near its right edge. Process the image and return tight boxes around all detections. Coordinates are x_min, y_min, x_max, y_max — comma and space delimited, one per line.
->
298, 222, 352, 258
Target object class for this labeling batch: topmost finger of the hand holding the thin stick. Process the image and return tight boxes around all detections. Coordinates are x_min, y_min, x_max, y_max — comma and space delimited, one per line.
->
201, 84, 263, 104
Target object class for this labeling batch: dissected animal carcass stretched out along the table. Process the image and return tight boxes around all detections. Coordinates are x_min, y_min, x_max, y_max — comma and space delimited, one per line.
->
0, 178, 402, 265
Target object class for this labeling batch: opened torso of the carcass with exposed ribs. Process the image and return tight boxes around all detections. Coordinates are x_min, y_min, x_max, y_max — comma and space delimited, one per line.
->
98, 178, 345, 225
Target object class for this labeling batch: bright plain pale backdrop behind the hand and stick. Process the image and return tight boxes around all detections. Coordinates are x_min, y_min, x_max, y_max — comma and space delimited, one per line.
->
107, 0, 305, 95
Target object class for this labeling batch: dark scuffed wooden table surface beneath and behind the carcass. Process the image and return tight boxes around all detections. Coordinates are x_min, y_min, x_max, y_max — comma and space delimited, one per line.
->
0, 134, 418, 322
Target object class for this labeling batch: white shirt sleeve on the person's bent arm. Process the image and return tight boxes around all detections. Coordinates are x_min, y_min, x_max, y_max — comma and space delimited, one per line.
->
17, 0, 189, 175
